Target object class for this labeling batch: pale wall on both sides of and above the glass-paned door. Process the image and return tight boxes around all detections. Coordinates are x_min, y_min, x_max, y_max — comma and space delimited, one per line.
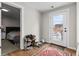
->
41, 4, 76, 49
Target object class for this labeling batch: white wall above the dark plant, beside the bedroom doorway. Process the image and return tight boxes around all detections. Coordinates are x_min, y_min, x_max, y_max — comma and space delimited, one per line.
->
23, 6, 39, 39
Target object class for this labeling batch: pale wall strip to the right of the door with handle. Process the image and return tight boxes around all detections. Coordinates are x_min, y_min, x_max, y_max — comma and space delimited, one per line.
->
69, 5, 77, 49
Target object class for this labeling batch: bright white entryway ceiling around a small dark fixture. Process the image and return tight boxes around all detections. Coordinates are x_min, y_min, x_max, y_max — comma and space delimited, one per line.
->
24, 2, 72, 12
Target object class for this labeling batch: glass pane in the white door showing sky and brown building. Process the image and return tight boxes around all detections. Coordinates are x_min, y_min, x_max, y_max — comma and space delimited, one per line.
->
50, 15, 64, 40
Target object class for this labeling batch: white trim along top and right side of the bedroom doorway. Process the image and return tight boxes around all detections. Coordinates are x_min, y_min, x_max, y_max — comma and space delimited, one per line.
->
3, 2, 24, 49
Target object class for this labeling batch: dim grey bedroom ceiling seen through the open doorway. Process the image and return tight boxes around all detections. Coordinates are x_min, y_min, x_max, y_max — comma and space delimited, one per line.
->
2, 3, 20, 19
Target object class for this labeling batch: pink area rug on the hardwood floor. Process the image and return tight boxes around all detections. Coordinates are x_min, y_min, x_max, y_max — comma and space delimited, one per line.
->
38, 47, 67, 56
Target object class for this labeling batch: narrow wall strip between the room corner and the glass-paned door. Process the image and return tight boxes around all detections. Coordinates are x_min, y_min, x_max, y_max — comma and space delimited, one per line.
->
41, 13, 49, 42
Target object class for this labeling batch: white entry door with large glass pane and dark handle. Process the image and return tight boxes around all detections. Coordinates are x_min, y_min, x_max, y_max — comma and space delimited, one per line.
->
49, 9, 69, 47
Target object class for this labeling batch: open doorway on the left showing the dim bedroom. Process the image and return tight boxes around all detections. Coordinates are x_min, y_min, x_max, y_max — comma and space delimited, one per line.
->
1, 3, 21, 55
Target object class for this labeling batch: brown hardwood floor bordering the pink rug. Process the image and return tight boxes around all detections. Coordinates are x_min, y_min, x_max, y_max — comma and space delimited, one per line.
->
7, 44, 76, 56
